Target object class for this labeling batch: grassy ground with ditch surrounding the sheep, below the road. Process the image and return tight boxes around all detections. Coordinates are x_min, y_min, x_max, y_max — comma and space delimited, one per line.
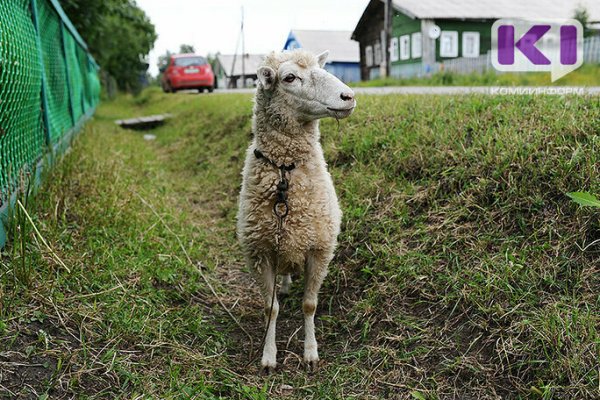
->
0, 89, 600, 399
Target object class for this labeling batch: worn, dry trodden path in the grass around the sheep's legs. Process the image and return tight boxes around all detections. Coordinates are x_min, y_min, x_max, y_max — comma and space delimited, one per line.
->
152, 134, 378, 398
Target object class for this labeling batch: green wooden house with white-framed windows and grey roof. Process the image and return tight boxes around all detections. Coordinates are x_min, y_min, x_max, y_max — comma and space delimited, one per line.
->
352, 0, 600, 80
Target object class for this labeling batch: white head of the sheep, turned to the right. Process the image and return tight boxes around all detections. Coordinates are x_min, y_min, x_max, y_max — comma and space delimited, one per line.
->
257, 49, 356, 122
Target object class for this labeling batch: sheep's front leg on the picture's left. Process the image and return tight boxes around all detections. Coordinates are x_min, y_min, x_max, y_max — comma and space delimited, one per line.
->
261, 263, 279, 374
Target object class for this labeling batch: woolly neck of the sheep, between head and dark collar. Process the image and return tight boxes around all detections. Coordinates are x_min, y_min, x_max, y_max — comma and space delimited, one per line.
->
254, 102, 319, 165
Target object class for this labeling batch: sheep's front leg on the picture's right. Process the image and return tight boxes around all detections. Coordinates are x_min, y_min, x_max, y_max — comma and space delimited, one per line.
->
302, 251, 332, 371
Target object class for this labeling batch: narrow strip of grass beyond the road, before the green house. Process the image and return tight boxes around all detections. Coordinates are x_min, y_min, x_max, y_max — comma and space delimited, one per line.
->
353, 64, 600, 87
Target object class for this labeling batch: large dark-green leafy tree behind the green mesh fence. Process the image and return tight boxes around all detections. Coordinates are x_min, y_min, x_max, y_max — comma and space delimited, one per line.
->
61, 0, 156, 92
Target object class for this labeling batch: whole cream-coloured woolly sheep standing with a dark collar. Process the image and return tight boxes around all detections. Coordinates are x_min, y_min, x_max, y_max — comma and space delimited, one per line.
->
237, 49, 356, 374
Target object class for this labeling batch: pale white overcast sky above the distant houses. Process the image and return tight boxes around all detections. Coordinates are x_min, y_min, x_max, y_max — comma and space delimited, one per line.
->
137, 0, 369, 75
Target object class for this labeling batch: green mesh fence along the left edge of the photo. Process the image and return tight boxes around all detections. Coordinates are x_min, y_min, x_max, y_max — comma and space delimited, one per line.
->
0, 0, 100, 247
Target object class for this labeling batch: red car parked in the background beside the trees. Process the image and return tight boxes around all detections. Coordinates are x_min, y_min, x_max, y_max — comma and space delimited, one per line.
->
161, 54, 215, 93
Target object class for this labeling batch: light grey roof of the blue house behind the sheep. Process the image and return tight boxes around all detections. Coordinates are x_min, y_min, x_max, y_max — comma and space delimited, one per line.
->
284, 29, 360, 63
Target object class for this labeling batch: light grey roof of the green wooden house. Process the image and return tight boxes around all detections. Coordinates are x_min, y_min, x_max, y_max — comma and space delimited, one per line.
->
392, 0, 600, 22
